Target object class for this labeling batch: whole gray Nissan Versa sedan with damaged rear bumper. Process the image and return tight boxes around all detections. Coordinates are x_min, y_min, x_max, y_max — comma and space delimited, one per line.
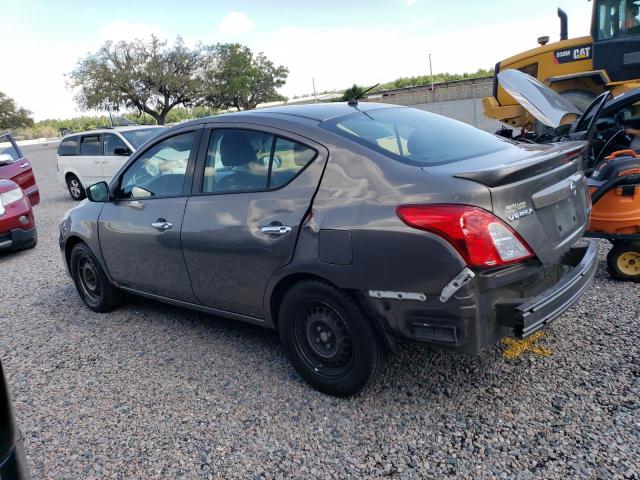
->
60, 103, 597, 395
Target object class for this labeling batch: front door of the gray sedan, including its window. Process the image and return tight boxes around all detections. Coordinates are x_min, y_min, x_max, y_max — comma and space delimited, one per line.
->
98, 129, 201, 302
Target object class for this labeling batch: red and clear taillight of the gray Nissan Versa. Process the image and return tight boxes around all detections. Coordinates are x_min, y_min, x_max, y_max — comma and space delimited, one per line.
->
396, 204, 534, 267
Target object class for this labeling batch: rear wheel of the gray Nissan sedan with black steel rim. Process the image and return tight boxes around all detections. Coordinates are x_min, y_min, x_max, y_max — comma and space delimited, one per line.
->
278, 280, 384, 397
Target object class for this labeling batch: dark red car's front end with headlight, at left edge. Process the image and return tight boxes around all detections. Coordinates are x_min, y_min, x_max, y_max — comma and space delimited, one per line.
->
0, 178, 38, 251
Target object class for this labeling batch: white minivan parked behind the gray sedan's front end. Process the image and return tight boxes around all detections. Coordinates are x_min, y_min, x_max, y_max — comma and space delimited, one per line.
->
57, 125, 167, 200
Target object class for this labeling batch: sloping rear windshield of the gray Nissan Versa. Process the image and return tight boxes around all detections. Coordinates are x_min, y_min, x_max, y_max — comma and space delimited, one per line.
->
321, 107, 510, 166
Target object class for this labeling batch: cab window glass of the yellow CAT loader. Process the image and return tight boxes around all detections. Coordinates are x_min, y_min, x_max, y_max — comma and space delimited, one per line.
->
596, 0, 640, 40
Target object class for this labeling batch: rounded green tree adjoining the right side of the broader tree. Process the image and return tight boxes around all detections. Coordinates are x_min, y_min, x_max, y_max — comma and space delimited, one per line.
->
202, 43, 289, 110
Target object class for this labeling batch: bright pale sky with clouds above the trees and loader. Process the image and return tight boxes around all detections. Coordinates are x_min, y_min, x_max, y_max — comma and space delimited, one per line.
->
0, 0, 592, 119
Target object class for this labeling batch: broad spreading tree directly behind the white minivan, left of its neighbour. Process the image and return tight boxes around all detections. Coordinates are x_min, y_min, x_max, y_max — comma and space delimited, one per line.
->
68, 36, 202, 125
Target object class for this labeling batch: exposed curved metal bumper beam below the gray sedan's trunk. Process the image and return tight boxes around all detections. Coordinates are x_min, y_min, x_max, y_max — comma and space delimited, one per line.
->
495, 242, 598, 337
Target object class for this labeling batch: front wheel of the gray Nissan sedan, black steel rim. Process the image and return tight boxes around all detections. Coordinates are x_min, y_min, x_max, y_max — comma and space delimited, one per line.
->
69, 243, 124, 312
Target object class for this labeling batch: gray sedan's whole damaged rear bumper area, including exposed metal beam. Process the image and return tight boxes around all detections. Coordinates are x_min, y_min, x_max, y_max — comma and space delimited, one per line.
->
363, 241, 598, 353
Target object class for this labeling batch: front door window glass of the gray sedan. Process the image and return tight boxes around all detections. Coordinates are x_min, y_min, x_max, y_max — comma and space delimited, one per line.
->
119, 132, 195, 198
